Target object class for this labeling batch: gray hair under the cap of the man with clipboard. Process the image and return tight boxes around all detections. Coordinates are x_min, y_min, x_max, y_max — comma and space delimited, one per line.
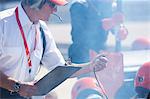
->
21, 0, 46, 10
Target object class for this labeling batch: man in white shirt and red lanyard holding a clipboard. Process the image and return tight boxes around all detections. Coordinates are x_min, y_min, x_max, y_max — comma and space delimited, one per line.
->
0, 0, 107, 99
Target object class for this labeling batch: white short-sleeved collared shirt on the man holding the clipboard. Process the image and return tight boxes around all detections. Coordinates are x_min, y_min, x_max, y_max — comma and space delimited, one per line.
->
0, 4, 65, 82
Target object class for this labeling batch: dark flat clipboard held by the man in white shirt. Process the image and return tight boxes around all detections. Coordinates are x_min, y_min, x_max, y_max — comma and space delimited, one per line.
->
34, 66, 81, 96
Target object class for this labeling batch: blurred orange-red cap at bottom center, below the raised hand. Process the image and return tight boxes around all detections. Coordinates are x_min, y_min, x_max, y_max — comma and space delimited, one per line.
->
71, 77, 103, 99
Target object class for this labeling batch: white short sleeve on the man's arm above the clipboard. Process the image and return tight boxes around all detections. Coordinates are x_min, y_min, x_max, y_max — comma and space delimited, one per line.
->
41, 21, 65, 70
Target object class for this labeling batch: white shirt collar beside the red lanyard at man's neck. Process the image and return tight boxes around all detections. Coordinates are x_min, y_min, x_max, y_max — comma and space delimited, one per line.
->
18, 3, 33, 26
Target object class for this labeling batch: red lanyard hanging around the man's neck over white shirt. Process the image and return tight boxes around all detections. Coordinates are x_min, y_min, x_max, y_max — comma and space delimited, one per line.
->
15, 7, 32, 73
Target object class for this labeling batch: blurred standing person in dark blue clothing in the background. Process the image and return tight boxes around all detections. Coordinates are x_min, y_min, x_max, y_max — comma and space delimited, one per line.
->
68, 0, 127, 63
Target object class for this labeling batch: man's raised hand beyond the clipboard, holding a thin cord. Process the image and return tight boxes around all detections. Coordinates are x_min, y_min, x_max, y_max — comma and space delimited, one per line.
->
91, 54, 108, 71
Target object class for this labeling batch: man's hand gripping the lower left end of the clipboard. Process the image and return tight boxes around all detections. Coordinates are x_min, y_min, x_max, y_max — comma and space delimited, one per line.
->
18, 83, 37, 97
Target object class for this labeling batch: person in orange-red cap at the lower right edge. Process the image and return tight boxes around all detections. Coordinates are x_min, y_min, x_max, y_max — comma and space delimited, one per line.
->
134, 62, 150, 99
